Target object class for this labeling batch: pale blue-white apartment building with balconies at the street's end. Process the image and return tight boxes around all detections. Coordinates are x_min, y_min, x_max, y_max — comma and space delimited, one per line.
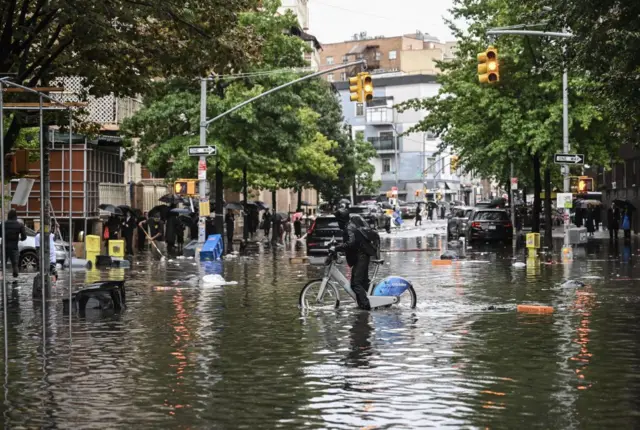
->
334, 74, 481, 204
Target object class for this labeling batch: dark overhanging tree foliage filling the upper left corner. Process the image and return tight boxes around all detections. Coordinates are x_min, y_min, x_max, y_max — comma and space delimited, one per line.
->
0, 0, 260, 151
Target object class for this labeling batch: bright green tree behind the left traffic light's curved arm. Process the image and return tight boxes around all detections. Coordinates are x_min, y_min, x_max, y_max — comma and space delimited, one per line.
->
123, 1, 341, 197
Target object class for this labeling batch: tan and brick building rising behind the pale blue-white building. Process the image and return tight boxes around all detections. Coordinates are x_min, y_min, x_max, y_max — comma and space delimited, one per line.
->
320, 32, 455, 82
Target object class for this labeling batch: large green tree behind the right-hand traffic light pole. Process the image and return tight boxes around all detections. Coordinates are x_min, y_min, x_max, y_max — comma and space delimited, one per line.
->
399, 0, 616, 235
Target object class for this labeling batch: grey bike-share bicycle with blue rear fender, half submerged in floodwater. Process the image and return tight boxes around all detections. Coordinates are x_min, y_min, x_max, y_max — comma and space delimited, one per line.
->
299, 242, 417, 309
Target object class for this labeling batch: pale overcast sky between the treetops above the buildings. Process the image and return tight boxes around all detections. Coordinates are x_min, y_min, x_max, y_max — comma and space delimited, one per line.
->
309, 0, 453, 44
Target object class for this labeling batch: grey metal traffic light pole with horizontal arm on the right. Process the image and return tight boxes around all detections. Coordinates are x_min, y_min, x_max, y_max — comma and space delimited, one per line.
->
487, 29, 573, 260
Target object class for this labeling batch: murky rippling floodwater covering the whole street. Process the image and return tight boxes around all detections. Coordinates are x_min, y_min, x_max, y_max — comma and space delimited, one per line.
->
0, 230, 640, 429
